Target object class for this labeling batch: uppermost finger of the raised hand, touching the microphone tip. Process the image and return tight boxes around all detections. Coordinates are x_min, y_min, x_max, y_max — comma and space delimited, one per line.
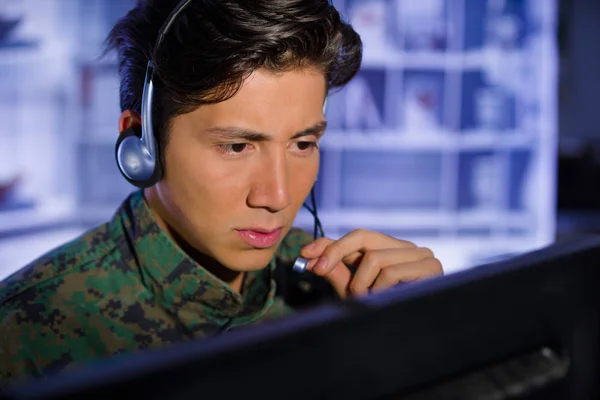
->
314, 229, 416, 274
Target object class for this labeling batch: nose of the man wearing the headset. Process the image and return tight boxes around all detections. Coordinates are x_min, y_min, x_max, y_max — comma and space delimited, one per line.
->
248, 152, 291, 212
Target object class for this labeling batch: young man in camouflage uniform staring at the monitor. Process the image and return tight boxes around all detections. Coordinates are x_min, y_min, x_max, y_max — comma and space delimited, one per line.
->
0, 0, 441, 383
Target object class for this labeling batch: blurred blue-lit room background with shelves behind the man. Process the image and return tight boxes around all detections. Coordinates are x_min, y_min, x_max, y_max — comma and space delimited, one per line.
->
0, 0, 600, 278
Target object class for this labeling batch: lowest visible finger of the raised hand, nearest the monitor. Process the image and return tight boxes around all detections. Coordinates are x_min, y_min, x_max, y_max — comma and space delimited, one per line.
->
371, 258, 442, 292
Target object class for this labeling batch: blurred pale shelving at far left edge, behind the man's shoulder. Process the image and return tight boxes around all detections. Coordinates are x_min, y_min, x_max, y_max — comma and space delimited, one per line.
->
0, 32, 74, 238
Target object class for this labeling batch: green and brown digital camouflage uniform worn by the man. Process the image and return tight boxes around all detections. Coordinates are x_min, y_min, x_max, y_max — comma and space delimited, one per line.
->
0, 191, 333, 385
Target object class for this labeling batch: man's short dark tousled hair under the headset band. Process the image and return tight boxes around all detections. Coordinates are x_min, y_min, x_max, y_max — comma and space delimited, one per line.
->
105, 0, 362, 153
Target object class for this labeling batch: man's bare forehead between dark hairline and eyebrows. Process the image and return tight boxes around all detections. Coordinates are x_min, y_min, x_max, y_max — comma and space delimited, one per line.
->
180, 67, 326, 135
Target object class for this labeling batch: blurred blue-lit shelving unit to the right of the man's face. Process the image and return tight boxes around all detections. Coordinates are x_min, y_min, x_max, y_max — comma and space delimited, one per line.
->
297, 0, 557, 269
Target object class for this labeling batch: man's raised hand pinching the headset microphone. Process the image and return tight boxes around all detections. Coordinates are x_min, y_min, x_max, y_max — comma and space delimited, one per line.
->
300, 229, 443, 298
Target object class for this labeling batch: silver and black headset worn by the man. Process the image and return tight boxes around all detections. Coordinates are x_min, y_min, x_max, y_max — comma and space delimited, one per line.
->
115, 0, 327, 239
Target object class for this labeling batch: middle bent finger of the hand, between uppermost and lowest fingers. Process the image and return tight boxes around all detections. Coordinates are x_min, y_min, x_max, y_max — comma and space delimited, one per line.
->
349, 247, 433, 296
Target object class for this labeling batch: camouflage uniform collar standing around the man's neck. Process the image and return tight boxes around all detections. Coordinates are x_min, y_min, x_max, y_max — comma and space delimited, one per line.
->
111, 190, 276, 329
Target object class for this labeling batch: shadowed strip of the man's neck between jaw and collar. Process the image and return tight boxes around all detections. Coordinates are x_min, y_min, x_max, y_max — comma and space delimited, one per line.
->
144, 189, 245, 293
